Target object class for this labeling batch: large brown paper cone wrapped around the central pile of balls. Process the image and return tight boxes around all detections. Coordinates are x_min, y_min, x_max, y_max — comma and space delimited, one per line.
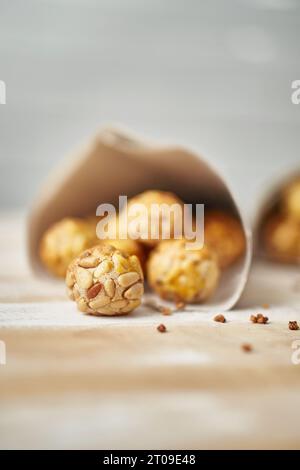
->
27, 128, 252, 311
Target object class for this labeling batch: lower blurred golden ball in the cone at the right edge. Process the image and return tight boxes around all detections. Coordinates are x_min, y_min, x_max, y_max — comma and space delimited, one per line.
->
262, 214, 300, 264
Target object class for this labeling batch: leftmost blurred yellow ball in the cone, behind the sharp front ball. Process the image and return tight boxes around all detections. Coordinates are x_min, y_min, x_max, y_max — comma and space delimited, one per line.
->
40, 217, 98, 277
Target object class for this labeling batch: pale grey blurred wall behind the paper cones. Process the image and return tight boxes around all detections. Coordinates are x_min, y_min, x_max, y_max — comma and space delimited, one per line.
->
0, 0, 300, 215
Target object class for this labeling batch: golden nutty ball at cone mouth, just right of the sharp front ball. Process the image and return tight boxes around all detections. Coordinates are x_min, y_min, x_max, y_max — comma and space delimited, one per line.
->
147, 240, 220, 303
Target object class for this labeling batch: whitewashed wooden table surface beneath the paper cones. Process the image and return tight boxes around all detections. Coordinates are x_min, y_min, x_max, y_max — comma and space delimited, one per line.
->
0, 215, 300, 449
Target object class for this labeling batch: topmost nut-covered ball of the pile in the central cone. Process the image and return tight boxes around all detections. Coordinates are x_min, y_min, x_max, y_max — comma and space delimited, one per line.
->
119, 191, 183, 247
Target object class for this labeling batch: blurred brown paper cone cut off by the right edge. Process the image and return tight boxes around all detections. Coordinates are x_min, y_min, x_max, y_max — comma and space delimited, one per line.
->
253, 168, 300, 264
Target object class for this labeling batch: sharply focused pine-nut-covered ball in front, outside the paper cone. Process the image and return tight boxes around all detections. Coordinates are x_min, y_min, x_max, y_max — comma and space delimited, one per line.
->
66, 244, 144, 315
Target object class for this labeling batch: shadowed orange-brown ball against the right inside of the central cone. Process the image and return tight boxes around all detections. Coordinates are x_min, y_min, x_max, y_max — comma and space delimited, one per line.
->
204, 210, 246, 269
